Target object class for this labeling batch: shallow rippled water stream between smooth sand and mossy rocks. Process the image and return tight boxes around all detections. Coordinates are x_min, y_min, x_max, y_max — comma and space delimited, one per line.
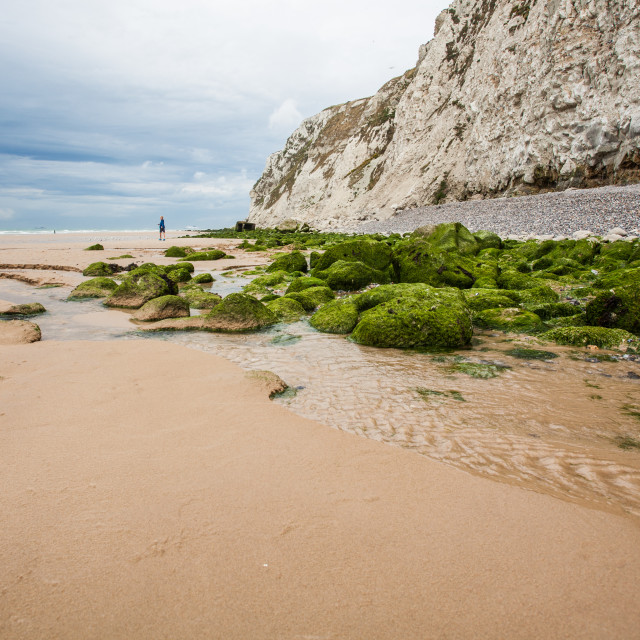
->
0, 274, 640, 516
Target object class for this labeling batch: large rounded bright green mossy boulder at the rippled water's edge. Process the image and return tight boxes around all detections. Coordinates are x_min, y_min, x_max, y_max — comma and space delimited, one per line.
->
351, 285, 473, 348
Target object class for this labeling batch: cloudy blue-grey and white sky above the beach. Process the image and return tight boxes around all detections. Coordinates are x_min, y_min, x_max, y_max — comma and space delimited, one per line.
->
0, 0, 449, 230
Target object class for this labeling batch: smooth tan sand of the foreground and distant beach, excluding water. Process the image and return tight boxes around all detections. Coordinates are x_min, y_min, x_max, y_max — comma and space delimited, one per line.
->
0, 232, 640, 639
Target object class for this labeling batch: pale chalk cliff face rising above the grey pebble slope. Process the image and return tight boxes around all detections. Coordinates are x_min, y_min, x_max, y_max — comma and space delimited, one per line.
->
249, 0, 640, 228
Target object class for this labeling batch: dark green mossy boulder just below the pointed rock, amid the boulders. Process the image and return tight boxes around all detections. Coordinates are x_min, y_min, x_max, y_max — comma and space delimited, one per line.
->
393, 238, 484, 289
